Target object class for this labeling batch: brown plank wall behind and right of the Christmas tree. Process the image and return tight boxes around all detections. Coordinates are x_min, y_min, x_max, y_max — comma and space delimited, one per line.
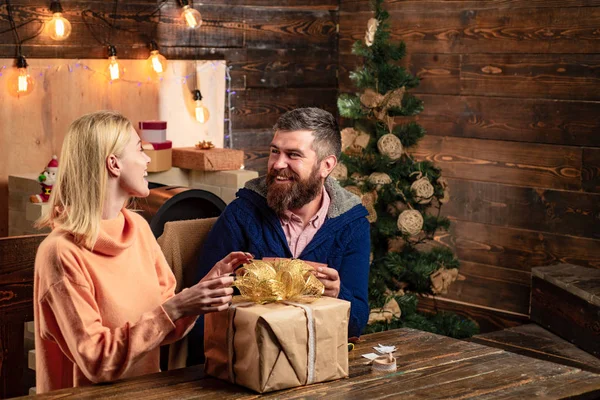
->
339, 0, 600, 331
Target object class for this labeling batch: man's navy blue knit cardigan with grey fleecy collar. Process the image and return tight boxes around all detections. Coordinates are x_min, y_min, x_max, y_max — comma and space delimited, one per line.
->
196, 177, 371, 337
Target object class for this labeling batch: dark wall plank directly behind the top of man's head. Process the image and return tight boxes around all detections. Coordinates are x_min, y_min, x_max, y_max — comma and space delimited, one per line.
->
234, 88, 337, 130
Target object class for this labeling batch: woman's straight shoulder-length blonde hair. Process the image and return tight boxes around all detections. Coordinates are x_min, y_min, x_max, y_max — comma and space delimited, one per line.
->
36, 111, 133, 249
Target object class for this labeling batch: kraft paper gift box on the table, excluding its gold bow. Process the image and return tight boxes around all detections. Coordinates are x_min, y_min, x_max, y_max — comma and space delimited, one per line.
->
204, 297, 350, 393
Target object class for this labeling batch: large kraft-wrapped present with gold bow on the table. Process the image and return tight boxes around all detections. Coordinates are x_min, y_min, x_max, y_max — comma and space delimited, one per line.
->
204, 259, 350, 393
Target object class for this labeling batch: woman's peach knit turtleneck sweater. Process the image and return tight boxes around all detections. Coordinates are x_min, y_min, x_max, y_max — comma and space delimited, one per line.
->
34, 209, 196, 393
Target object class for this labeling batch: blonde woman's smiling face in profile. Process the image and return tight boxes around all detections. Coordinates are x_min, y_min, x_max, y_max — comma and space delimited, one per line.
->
119, 128, 150, 197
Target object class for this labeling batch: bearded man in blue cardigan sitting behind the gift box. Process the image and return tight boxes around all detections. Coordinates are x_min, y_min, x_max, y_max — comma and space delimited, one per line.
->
189, 108, 371, 363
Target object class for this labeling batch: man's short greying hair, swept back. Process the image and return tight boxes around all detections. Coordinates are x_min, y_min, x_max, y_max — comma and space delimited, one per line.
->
273, 107, 342, 161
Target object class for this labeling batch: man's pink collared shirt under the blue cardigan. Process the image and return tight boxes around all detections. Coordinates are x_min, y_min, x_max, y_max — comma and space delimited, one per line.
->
279, 187, 331, 258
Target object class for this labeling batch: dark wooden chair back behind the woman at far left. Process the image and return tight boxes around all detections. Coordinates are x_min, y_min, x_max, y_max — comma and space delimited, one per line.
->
0, 235, 46, 398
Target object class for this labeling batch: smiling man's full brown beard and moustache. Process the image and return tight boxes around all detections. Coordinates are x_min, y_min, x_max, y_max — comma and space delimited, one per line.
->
267, 164, 323, 216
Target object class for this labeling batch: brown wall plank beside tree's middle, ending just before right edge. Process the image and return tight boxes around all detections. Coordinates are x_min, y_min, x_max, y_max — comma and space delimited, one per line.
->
410, 135, 582, 190
